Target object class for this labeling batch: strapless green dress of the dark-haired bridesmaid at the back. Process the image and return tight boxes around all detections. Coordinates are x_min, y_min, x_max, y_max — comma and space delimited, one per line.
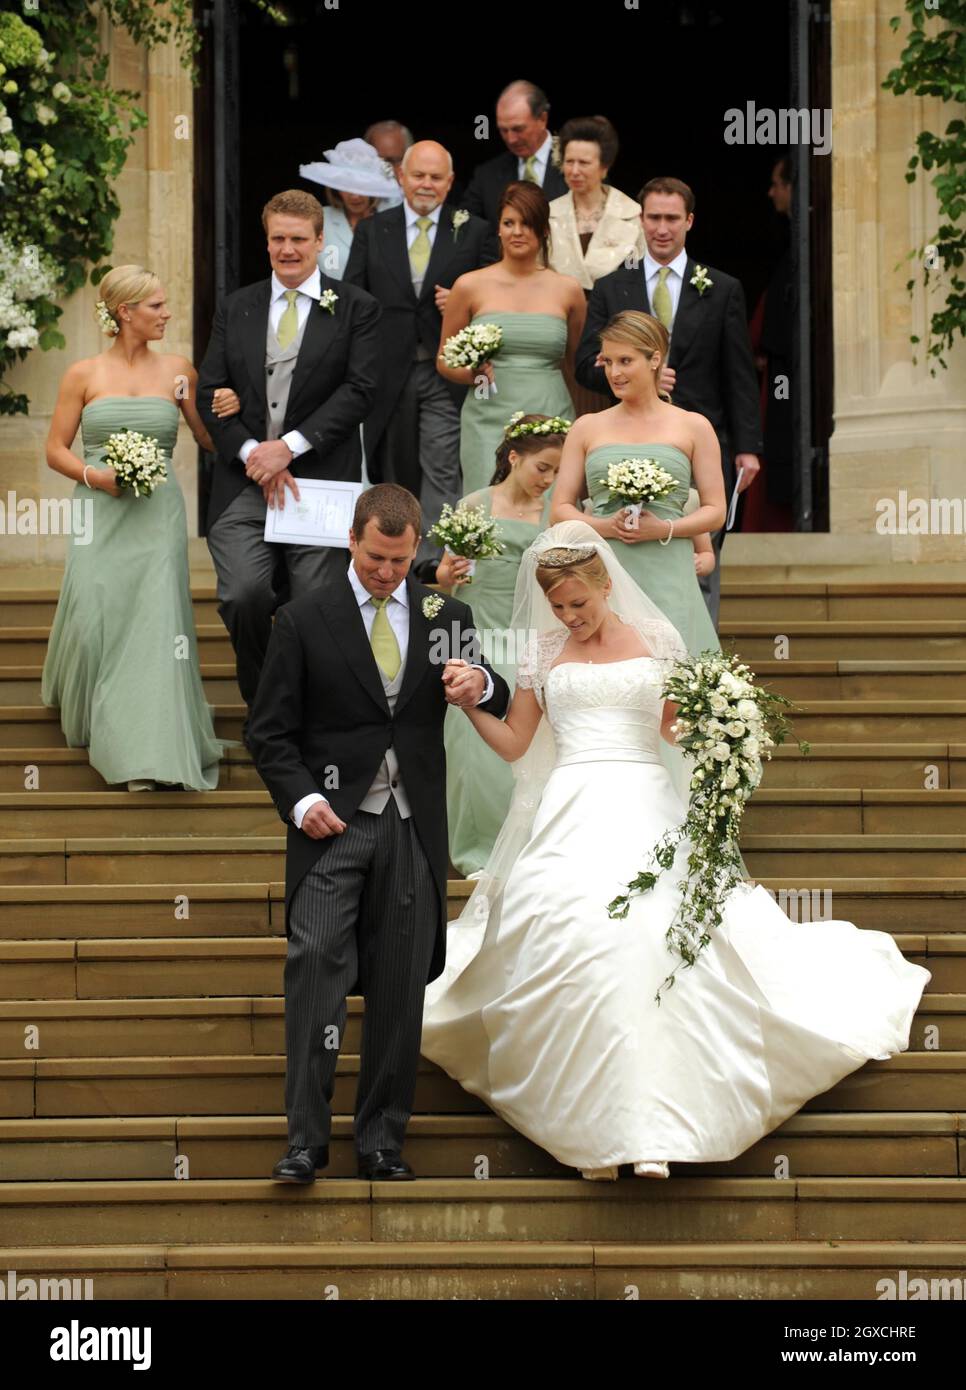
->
460, 313, 574, 492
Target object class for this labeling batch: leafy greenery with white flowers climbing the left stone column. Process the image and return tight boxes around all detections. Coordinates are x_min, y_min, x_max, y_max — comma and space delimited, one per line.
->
0, 0, 285, 414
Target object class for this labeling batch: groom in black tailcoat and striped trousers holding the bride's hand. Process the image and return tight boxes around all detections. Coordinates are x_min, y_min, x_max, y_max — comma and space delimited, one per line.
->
249, 484, 509, 1183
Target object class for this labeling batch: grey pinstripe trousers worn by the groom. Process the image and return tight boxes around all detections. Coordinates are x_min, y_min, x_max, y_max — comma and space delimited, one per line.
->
285, 796, 438, 1154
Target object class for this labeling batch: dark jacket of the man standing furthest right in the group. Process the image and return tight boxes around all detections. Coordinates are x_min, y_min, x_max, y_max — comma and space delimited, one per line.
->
575, 256, 762, 453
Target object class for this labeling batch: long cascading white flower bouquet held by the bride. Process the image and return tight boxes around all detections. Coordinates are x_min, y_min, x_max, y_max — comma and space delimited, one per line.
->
607, 651, 809, 1004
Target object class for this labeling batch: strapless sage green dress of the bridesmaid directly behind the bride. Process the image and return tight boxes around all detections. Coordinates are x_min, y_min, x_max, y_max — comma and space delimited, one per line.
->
585, 443, 721, 656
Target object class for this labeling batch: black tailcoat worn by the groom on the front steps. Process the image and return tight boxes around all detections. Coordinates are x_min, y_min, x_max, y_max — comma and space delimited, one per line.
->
249, 575, 510, 980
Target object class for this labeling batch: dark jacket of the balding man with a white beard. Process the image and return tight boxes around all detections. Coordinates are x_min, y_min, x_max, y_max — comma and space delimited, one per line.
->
342, 203, 498, 459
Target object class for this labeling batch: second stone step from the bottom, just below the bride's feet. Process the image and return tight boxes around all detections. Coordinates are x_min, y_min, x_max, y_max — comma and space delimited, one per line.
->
0, 1176, 966, 1250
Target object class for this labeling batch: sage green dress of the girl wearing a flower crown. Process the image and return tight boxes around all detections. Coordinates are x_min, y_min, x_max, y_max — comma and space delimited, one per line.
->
443, 488, 553, 874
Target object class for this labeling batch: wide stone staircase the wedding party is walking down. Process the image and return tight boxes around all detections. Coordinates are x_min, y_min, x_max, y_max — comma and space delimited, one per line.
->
0, 580, 966, 1300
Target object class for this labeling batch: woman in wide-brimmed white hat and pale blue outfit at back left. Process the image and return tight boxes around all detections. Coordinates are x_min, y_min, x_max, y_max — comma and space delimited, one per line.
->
299, 139, 402, 279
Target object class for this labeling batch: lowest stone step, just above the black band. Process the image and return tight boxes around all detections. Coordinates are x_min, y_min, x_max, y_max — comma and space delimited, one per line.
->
0, 1240, 966, 1302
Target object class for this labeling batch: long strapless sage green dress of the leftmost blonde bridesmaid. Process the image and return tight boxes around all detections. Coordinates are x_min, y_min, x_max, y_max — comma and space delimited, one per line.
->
40, 396, 224, 791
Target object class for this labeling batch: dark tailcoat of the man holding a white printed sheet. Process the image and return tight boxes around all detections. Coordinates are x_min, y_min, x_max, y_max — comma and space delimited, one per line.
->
197, 274, 381, 530
